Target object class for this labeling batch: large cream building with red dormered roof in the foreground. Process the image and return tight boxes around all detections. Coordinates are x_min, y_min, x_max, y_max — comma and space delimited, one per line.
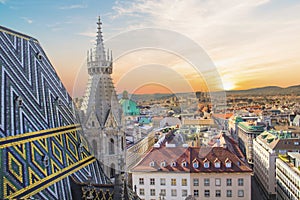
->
131, 147, 252, 200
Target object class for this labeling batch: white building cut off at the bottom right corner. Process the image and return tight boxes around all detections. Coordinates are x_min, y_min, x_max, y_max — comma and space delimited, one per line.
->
276, 152, 300, 200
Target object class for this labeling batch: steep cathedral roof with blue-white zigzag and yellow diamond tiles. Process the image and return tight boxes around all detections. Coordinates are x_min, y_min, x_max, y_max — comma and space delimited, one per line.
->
0, 26, 109, 199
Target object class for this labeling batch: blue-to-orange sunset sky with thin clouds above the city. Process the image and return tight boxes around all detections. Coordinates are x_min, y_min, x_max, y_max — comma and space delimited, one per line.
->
0, 0, 300, 96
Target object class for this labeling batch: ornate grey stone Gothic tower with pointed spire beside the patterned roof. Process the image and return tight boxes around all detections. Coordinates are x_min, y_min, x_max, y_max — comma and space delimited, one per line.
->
81, 17, 125, 178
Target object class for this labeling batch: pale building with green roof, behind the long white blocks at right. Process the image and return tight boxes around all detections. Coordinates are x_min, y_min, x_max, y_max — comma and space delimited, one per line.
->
238, 122, 264, 164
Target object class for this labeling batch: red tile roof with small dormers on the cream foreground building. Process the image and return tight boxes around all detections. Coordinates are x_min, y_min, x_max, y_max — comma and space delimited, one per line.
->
132, 147, 252, 173
